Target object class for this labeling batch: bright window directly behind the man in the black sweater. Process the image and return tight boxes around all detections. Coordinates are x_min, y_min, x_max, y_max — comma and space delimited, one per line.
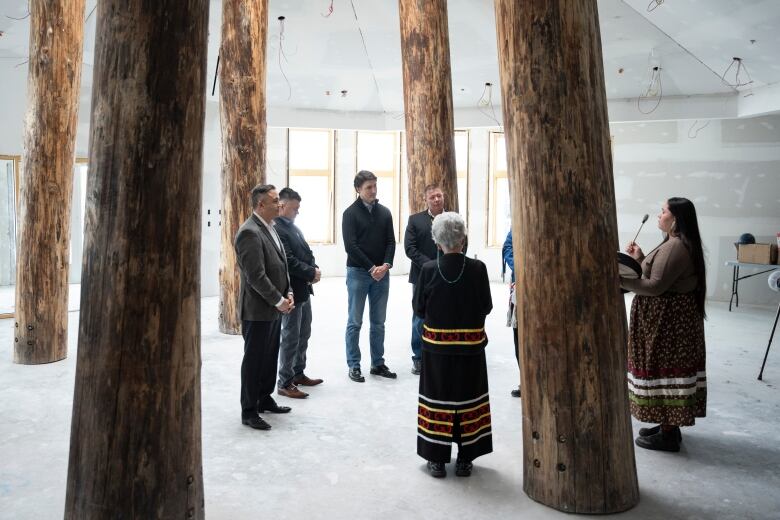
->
357, 131, 401, 241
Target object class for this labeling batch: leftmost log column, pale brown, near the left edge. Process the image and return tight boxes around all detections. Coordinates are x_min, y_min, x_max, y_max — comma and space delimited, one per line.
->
14, 0, 84, 365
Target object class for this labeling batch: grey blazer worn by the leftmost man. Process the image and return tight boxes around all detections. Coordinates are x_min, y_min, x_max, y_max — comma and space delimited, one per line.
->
234, 213, 290, 321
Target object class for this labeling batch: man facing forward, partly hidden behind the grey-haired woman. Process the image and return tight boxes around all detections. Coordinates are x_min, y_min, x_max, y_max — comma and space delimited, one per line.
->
404, 184, 444, 375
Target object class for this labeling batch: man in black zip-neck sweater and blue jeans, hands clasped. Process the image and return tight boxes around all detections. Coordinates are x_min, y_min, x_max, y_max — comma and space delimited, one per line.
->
341, 170, 396, 383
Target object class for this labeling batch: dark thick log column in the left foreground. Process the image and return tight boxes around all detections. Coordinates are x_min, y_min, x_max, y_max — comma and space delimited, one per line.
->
65, 0, 209, 519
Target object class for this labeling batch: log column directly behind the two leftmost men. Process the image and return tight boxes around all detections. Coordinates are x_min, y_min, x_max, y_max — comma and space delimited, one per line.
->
219, 0, 270, 334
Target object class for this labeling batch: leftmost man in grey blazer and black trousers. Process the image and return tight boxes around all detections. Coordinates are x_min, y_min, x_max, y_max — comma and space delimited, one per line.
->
234, 184, 295, 430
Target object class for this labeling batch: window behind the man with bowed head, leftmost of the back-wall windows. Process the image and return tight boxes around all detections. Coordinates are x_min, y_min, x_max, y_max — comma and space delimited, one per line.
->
287, 128, 334, 244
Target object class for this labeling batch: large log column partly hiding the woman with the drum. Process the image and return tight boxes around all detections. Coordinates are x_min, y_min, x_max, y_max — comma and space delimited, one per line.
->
495, 0, 639, 513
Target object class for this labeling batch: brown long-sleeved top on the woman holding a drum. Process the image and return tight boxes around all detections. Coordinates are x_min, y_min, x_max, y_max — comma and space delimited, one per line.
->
620, 237, 697, 296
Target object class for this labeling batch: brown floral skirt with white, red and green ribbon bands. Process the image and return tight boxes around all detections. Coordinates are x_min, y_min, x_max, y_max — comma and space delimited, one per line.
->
628, 293, 707, 426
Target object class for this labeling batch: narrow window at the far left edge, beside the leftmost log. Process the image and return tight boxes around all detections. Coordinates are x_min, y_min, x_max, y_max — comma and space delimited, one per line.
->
0, 155, 21, 318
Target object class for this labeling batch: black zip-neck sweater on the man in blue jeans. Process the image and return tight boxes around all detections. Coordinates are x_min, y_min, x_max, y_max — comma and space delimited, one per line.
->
341, 197, 395, 270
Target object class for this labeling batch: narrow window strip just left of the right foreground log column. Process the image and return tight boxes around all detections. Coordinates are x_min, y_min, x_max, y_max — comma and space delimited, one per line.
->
487, 132, 512, 247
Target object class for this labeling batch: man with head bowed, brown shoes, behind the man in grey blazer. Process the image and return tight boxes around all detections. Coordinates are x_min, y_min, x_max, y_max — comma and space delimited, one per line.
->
274, 188, 322, 399
